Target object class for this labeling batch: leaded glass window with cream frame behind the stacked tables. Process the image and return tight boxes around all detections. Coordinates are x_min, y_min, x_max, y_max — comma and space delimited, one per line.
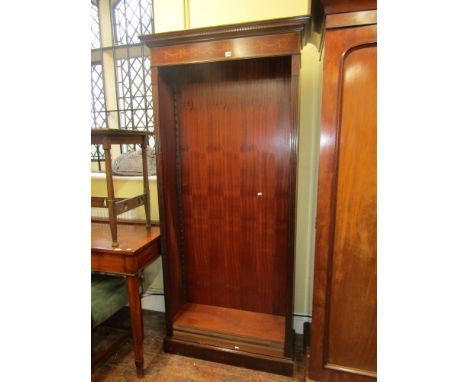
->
91, 0, 155, 167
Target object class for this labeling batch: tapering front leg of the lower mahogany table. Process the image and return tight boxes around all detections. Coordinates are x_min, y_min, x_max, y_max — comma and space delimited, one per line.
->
127, 275, 143, 378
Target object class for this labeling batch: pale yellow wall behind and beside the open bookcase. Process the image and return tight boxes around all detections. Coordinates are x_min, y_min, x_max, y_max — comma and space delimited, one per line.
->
93, 0, 322, 315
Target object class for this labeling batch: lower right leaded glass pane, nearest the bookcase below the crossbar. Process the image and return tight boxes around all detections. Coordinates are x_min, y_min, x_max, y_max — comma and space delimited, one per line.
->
115, 57, 154, 152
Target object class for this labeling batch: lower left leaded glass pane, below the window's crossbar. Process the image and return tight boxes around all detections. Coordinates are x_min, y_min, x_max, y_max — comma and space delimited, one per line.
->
91, 64, 107, 161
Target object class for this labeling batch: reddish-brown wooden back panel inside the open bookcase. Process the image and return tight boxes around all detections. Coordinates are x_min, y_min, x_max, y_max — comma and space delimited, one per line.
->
167, 57, 292, 314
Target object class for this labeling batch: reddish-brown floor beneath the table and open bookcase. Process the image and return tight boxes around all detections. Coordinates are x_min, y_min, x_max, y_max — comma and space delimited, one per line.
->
92, 309, 304, 382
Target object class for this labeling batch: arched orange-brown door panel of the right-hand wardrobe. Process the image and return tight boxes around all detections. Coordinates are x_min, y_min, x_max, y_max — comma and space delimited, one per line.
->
327, 45, 377, 372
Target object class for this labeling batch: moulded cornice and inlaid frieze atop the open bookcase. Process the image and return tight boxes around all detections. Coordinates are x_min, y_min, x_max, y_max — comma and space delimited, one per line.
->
141, 16, 310, 67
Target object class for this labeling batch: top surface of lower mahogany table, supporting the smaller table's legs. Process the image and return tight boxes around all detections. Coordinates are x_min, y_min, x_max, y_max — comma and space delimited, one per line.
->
91, 222, 160, 256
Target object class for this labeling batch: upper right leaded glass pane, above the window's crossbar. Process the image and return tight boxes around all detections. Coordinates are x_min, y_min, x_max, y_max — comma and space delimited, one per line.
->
114, 0, 153, 45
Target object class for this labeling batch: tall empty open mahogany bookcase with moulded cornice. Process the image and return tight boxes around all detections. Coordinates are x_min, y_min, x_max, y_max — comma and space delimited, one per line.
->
142, 16, 309, 375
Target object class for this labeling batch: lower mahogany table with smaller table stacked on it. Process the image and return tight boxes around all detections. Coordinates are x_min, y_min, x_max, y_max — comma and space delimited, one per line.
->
91, 222, 161, 378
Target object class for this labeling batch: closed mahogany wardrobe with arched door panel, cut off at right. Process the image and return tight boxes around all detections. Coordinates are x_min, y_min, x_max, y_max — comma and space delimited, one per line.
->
306, 0, 377, 382
